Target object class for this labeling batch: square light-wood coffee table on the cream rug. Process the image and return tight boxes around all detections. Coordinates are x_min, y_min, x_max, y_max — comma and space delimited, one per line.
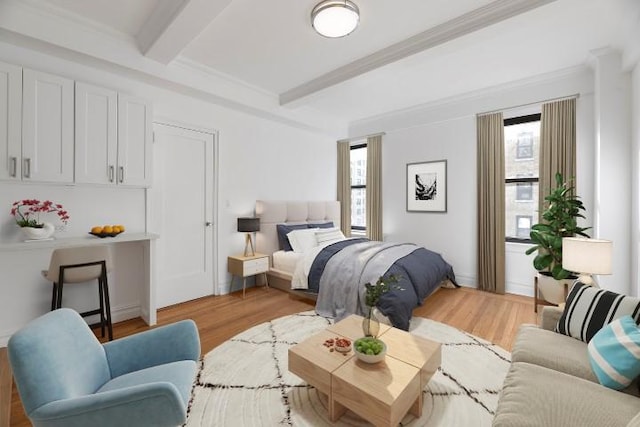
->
289, 315, 441, 426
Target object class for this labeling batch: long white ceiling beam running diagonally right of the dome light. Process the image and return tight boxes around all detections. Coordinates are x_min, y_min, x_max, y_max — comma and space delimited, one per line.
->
279, 0, 556, 105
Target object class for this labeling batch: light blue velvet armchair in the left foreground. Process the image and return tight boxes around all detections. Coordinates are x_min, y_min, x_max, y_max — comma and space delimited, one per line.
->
7, 308, 200, 427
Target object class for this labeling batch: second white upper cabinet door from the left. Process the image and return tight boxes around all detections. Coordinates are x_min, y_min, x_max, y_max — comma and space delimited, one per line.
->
22, 69, 74, 182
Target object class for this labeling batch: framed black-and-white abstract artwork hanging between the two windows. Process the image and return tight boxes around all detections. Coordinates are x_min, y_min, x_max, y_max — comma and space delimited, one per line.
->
407, 160, 447, 213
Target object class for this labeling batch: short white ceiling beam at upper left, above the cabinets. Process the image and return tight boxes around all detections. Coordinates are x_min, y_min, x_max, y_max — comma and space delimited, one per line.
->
137, 0, 232, 65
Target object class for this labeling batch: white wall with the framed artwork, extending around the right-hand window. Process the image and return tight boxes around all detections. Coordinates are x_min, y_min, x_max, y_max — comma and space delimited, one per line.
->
349, 67, 594, 295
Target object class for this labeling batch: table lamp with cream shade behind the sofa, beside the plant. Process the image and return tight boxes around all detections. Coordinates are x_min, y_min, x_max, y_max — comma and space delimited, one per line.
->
562, 237, 613, 286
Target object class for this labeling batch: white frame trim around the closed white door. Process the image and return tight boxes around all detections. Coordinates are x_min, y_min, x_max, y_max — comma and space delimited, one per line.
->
145, 117, 220, 295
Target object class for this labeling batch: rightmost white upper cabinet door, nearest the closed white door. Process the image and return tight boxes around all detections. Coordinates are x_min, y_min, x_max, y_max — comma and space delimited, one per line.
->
116, 94, 153, 187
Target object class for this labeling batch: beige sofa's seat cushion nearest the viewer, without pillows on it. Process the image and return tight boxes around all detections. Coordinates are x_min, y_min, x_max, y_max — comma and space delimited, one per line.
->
493, 362, 640, 427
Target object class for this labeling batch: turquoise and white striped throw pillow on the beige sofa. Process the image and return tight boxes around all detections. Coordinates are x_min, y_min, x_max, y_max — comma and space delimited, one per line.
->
587, 316, 640, 390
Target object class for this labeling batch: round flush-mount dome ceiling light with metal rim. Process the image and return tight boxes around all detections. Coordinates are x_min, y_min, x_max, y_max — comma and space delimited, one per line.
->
311, 0, 360, 38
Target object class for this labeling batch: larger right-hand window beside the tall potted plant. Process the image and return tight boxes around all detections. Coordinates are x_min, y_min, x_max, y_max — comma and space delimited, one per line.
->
504, 114, 540, 243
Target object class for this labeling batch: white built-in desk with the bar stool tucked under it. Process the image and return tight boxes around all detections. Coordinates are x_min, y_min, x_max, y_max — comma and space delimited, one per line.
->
0, 232, 159, 347
